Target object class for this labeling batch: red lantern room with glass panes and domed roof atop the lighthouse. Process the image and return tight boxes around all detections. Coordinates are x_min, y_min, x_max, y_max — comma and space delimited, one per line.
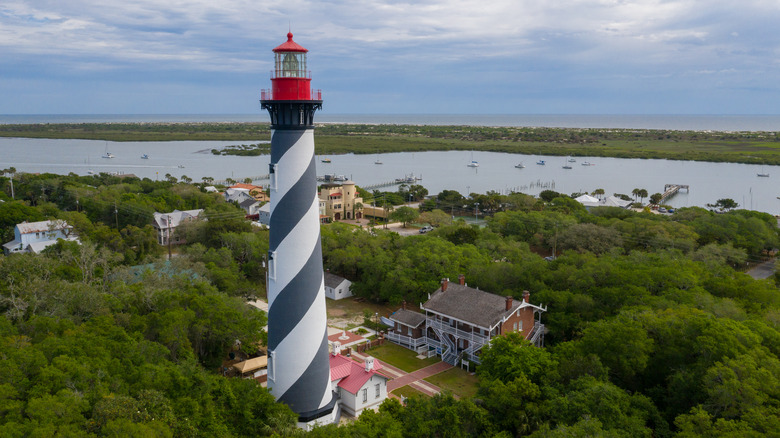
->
262, 32, 322, 100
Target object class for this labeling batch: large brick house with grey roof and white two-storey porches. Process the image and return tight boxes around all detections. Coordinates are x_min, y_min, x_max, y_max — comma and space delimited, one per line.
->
387, 275, 547, 365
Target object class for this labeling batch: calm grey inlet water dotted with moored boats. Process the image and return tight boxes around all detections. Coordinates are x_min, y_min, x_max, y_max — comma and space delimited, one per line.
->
0, 138, 780, 214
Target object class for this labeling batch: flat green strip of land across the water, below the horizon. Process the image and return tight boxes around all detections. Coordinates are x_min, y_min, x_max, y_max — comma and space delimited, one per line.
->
0, 122, 780, 165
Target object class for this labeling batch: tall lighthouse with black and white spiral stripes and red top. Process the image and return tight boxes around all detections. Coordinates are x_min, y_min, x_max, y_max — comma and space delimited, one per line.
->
260, 33, 340, 428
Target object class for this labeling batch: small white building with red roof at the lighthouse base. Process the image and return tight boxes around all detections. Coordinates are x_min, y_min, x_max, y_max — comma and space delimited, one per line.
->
330, 343, 389, 417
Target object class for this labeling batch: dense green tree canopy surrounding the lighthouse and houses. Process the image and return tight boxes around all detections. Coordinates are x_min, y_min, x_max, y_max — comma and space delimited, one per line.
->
0, 170, 780, 437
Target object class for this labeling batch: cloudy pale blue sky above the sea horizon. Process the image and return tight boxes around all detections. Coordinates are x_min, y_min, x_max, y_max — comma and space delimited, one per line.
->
0, 0, 780, 114
